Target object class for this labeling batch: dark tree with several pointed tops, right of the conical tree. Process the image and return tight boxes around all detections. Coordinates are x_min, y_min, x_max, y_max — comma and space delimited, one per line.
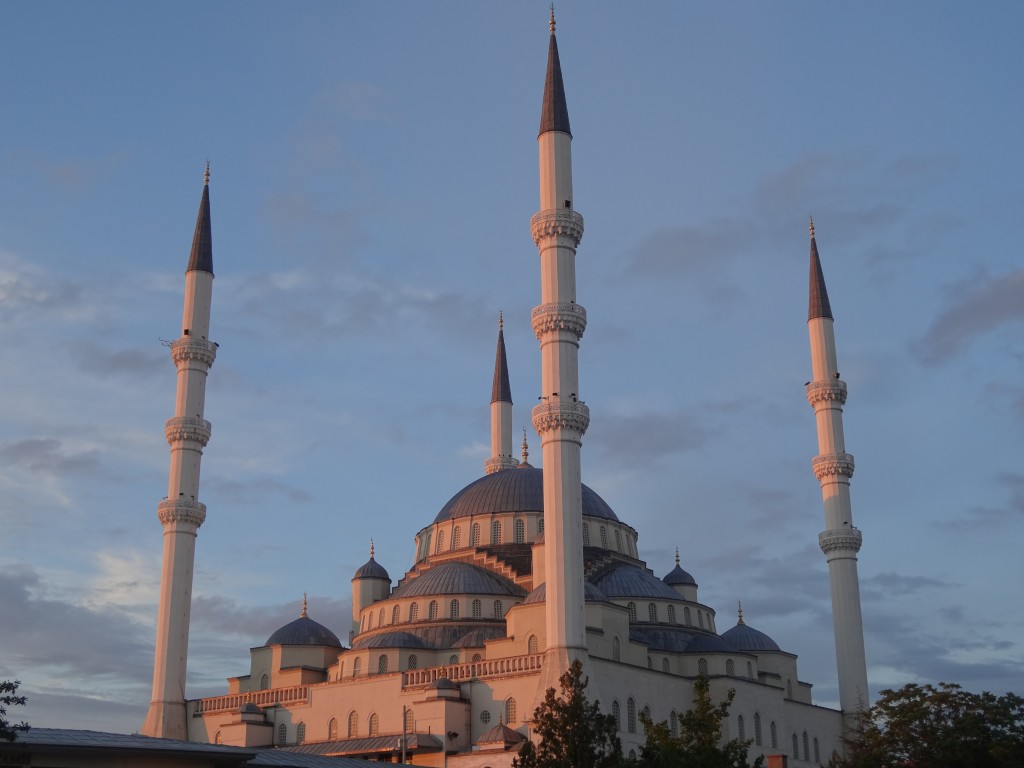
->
640, 675, 764, 768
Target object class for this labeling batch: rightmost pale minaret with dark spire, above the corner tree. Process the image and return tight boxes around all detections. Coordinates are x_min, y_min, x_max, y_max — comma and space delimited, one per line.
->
807, 220, 868, 725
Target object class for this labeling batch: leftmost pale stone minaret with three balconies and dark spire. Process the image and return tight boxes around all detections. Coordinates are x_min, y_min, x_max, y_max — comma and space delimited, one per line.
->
142, 164, 217, 739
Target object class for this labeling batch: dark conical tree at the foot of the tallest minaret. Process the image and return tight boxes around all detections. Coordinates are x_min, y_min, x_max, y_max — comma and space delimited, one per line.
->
512, 660, 623, 768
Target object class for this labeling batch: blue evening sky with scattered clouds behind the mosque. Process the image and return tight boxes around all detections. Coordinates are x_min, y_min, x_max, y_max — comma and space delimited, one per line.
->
0, 0, 1024, 732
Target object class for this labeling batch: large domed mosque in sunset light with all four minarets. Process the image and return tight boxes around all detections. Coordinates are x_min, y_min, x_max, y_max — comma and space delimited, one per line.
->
142, 14, 867, 768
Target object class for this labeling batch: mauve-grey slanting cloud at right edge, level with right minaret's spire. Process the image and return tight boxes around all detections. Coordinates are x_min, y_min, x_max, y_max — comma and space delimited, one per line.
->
914, 268, 1024, 365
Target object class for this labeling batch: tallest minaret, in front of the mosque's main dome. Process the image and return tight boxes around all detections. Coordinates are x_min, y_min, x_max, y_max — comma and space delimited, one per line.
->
530, 10, 590, 679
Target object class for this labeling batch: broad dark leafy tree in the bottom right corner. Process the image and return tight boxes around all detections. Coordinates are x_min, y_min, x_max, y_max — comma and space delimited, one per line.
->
840, 683, 1024, 768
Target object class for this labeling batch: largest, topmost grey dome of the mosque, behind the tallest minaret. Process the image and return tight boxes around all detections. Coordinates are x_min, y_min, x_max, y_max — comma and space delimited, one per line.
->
434, 467, 618, 523
